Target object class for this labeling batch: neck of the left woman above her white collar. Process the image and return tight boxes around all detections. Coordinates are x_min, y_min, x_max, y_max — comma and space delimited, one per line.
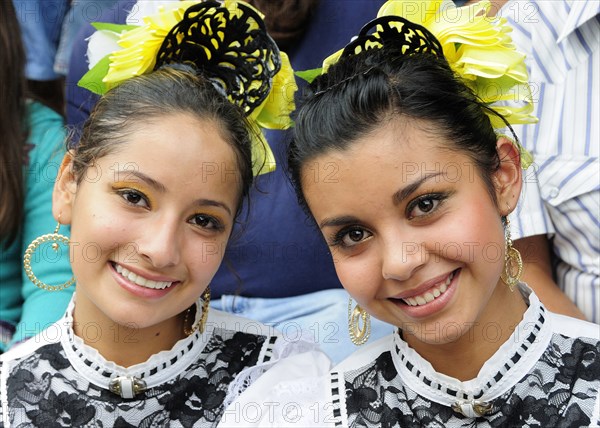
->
73, 299, 186, 367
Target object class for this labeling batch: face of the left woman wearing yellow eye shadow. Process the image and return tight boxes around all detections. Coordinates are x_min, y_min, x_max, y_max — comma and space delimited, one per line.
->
53, 114, 241, 328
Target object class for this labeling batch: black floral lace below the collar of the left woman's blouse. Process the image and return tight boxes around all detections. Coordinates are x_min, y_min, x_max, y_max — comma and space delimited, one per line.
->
1, 328, 268, 428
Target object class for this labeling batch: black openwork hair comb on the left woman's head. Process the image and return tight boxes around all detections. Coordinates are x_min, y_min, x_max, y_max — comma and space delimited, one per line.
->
154, 1, 281, 115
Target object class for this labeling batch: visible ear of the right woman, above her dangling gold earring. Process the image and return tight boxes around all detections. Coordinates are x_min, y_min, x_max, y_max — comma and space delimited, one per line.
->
492, 137, 523, 216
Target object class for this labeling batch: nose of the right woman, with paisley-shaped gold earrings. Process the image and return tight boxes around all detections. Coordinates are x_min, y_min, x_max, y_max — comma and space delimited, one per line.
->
381, 237, 429, 281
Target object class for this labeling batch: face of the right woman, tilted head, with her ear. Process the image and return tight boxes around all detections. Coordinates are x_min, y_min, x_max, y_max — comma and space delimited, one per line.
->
302, 119, 520, 344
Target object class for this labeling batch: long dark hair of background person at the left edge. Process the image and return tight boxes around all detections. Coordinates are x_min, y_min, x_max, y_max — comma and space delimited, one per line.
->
0, 1, 27, 246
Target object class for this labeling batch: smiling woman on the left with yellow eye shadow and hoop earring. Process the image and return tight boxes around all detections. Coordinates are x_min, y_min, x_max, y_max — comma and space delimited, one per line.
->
0, 2, 326, 428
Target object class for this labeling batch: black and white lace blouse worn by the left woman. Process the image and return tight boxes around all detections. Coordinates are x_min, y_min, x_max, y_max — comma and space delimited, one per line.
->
0, 294, 310, 428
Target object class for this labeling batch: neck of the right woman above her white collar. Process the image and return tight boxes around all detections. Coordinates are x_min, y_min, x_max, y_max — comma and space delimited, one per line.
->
404, 283, 527, 381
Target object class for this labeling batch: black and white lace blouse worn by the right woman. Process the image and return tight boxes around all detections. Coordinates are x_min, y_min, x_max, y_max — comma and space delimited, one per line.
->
330, 286, 600, 428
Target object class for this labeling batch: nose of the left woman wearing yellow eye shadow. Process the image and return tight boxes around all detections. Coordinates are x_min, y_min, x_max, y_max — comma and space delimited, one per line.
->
137, 216, 182, 268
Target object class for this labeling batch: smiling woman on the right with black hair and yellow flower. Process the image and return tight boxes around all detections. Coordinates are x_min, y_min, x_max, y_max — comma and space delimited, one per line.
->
223, 1, 600, 427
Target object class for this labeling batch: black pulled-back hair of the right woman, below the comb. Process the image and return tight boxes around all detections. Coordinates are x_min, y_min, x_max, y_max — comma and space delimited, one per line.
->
289, 48, 500, 207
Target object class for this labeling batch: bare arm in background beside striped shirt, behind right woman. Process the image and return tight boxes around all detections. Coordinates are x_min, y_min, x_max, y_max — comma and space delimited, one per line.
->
514, 235, 586, 319
